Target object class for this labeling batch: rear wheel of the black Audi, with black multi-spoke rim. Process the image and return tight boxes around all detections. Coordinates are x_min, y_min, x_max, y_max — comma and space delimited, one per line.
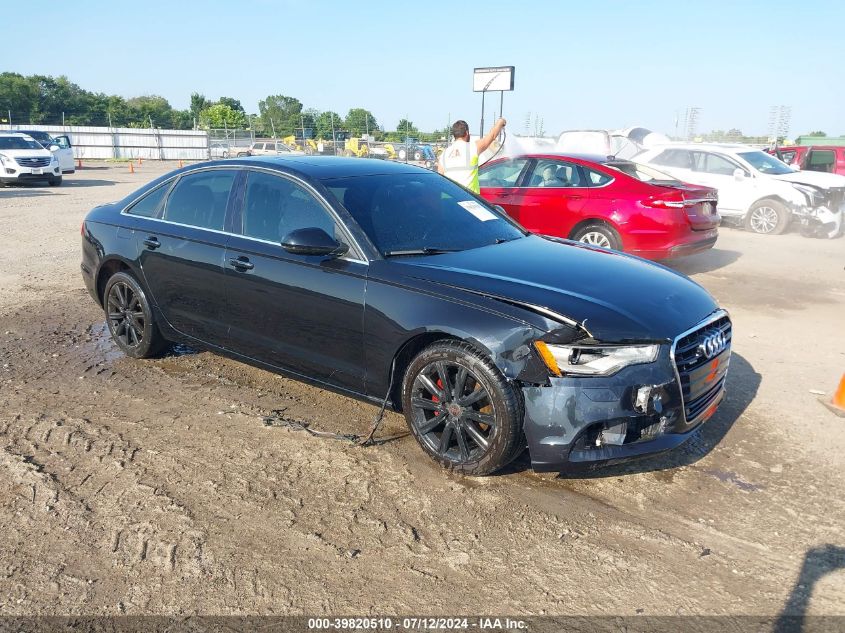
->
103, 272, 167, 358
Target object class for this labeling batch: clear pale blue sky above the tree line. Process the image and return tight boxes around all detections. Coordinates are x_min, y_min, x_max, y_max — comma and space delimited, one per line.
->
0, 0, 845, 136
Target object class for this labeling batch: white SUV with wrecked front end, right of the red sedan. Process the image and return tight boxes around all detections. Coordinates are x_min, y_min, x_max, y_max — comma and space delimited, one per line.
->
634, 143, 845, 235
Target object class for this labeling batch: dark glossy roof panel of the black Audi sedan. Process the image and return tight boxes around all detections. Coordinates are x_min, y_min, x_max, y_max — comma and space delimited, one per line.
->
218, 155, 432, 180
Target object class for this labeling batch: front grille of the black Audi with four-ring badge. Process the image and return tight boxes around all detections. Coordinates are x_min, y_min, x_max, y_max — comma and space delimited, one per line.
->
673, 315, 731, 426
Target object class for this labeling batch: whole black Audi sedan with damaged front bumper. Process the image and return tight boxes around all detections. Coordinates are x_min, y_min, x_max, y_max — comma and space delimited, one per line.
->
82, 156, 731, 475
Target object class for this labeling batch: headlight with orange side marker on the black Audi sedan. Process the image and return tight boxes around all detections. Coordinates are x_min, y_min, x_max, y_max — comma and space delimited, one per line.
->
534, 341, 660, 376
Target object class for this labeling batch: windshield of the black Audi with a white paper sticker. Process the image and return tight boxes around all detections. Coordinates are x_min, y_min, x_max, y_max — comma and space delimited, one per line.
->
323, 173, 525, 255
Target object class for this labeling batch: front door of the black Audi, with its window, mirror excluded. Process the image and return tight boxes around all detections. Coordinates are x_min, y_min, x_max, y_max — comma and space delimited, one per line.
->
225, 170, 368, 392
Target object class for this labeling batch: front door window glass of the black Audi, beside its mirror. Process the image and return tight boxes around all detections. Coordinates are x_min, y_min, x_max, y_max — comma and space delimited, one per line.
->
242, 171, 341, 244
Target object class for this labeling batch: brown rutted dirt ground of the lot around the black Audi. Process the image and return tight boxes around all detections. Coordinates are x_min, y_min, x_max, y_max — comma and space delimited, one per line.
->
0, 163, 845, 615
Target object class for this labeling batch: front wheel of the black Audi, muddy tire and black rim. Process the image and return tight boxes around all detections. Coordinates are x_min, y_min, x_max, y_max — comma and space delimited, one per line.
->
402, 341, 525, 476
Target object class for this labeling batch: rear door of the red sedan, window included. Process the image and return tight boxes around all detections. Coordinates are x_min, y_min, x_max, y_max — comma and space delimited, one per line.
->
519, 158, 590, 237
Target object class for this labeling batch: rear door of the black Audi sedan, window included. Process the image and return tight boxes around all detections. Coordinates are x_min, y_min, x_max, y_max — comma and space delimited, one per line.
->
135, 169, 238, 346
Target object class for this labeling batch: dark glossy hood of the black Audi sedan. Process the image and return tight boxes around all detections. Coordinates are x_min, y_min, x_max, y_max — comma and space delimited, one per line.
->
391, 235, 718, 342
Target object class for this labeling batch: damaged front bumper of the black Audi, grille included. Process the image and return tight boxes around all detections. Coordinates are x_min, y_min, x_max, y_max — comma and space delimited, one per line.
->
523, 312, 731, 471
